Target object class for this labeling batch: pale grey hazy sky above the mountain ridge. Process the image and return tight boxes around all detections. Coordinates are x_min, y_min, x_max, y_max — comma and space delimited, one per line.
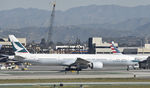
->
0, 0, 150, 11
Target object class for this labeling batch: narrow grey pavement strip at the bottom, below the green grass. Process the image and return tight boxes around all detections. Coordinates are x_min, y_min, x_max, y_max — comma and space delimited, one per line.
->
0, 82, 150, 86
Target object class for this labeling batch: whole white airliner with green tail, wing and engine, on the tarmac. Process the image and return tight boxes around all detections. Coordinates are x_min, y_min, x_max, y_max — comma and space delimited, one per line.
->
9, 35, 137, 72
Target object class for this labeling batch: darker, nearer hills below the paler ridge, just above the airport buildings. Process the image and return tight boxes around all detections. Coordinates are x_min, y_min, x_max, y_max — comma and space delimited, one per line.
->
0, 25, 130, 42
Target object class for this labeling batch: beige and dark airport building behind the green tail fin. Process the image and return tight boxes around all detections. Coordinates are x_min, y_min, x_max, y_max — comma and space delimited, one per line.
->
0, 38, 26, 55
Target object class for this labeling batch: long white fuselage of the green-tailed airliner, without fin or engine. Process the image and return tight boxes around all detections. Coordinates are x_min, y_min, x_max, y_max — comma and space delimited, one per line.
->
16, 54, 137, 66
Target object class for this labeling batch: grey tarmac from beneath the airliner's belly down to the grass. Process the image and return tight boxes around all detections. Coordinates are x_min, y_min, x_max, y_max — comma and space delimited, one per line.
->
0, 66, 150, 79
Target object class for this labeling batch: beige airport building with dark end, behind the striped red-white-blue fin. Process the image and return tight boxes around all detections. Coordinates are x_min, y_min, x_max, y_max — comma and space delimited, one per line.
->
88, 37, 150, 54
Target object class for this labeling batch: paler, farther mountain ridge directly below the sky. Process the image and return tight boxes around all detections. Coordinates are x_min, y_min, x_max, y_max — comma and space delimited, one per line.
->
0, 5, 150, 28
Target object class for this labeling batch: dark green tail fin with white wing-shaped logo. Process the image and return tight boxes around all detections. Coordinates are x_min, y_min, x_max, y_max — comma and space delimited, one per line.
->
9, 35, 29, 53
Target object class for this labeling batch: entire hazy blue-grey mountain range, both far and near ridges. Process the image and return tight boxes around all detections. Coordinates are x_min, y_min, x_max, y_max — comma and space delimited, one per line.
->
0, 5, 150, 41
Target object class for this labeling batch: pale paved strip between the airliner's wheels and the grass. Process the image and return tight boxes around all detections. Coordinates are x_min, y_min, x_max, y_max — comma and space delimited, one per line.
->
0, 70, 150, 79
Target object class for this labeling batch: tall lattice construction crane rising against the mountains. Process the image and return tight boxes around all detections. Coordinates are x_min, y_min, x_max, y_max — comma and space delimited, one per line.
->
47, 1, 56, 47
